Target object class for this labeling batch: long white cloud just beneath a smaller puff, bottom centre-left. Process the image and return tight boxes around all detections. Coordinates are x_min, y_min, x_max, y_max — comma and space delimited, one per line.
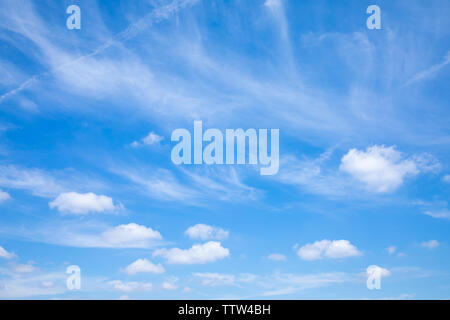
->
153, 241, 230, 264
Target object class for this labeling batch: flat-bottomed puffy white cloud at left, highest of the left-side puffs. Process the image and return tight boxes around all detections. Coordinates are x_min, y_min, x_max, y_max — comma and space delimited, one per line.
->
49, 192, 116, 214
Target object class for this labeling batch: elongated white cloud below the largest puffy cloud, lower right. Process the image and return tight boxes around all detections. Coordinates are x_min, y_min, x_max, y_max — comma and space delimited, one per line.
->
297, 239, 362, 261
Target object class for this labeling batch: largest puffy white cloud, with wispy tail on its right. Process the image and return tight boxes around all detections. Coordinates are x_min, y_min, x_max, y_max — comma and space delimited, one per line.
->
340, 145, 439, 192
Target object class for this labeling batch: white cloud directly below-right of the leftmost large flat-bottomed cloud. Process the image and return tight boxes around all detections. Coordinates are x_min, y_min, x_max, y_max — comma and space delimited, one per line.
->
102, 223, 162, 248
